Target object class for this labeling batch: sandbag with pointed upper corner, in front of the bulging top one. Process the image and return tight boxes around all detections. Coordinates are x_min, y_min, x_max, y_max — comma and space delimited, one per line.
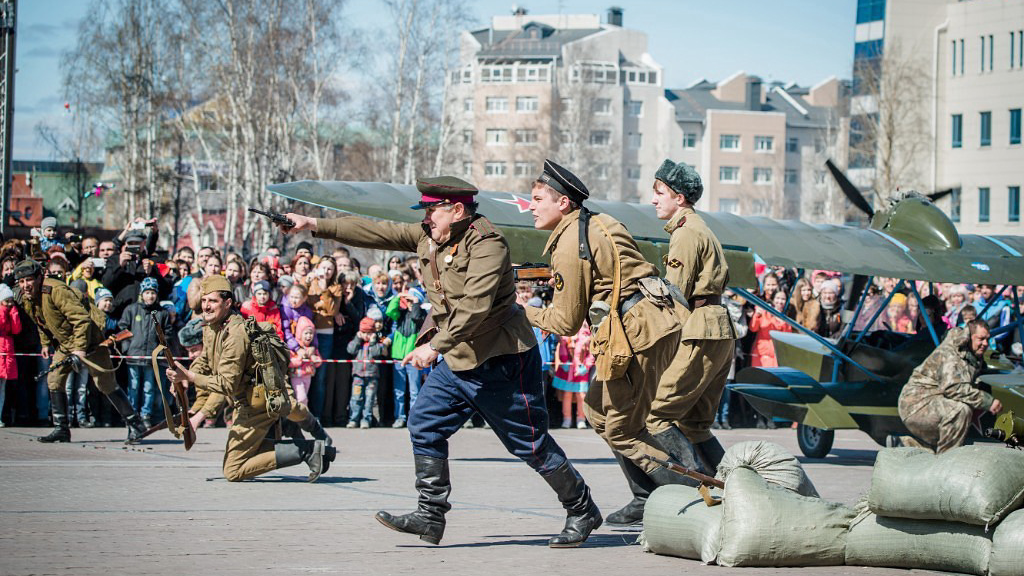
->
716, 466, 854, 566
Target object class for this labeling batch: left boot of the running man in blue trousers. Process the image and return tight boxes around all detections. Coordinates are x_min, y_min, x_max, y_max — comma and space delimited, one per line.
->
374, 456, 452, 544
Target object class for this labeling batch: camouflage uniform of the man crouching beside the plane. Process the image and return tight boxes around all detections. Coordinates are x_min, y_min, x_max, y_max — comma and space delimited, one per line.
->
899, 327, 993, 453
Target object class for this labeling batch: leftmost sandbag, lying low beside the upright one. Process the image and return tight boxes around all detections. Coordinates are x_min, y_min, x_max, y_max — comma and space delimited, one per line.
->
640, 485, 723, 564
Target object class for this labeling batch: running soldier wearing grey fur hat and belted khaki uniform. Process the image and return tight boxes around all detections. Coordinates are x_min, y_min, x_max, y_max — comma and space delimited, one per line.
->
624, 160, 736, 522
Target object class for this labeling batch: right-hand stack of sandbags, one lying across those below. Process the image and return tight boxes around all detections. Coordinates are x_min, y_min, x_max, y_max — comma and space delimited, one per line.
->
846, 446, 1024, 576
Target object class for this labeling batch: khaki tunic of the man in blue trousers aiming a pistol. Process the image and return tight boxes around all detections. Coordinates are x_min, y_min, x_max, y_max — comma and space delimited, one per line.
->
316, 215, 537, 364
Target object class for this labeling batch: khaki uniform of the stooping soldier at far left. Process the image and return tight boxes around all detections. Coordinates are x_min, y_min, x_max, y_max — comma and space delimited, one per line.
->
23, 278, 118, 395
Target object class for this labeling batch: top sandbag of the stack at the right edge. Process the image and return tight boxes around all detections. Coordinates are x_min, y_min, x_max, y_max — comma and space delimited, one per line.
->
867, 445, 1024, 526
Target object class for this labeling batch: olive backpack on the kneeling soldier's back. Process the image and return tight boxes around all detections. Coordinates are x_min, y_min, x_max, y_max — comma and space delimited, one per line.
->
245, 317, 292, 418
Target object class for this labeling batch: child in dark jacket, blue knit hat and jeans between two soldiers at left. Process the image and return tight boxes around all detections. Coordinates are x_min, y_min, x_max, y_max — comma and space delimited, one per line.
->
118, 278, 171, 427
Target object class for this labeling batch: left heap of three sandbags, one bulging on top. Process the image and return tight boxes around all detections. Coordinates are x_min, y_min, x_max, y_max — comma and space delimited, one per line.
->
641, 442, 854, 566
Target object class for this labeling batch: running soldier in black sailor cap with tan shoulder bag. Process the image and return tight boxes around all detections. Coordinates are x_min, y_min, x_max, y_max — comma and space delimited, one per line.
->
526, 160, 683, 518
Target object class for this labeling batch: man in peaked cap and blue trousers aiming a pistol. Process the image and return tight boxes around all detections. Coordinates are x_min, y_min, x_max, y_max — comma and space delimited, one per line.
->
276, 176, 603, 547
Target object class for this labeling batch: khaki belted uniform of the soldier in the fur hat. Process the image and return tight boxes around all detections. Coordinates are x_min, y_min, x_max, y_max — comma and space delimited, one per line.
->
647, 208, 736, 444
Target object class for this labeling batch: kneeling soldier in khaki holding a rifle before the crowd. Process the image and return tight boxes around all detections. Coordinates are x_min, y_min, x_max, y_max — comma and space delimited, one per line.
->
161, 276, 337, 482
